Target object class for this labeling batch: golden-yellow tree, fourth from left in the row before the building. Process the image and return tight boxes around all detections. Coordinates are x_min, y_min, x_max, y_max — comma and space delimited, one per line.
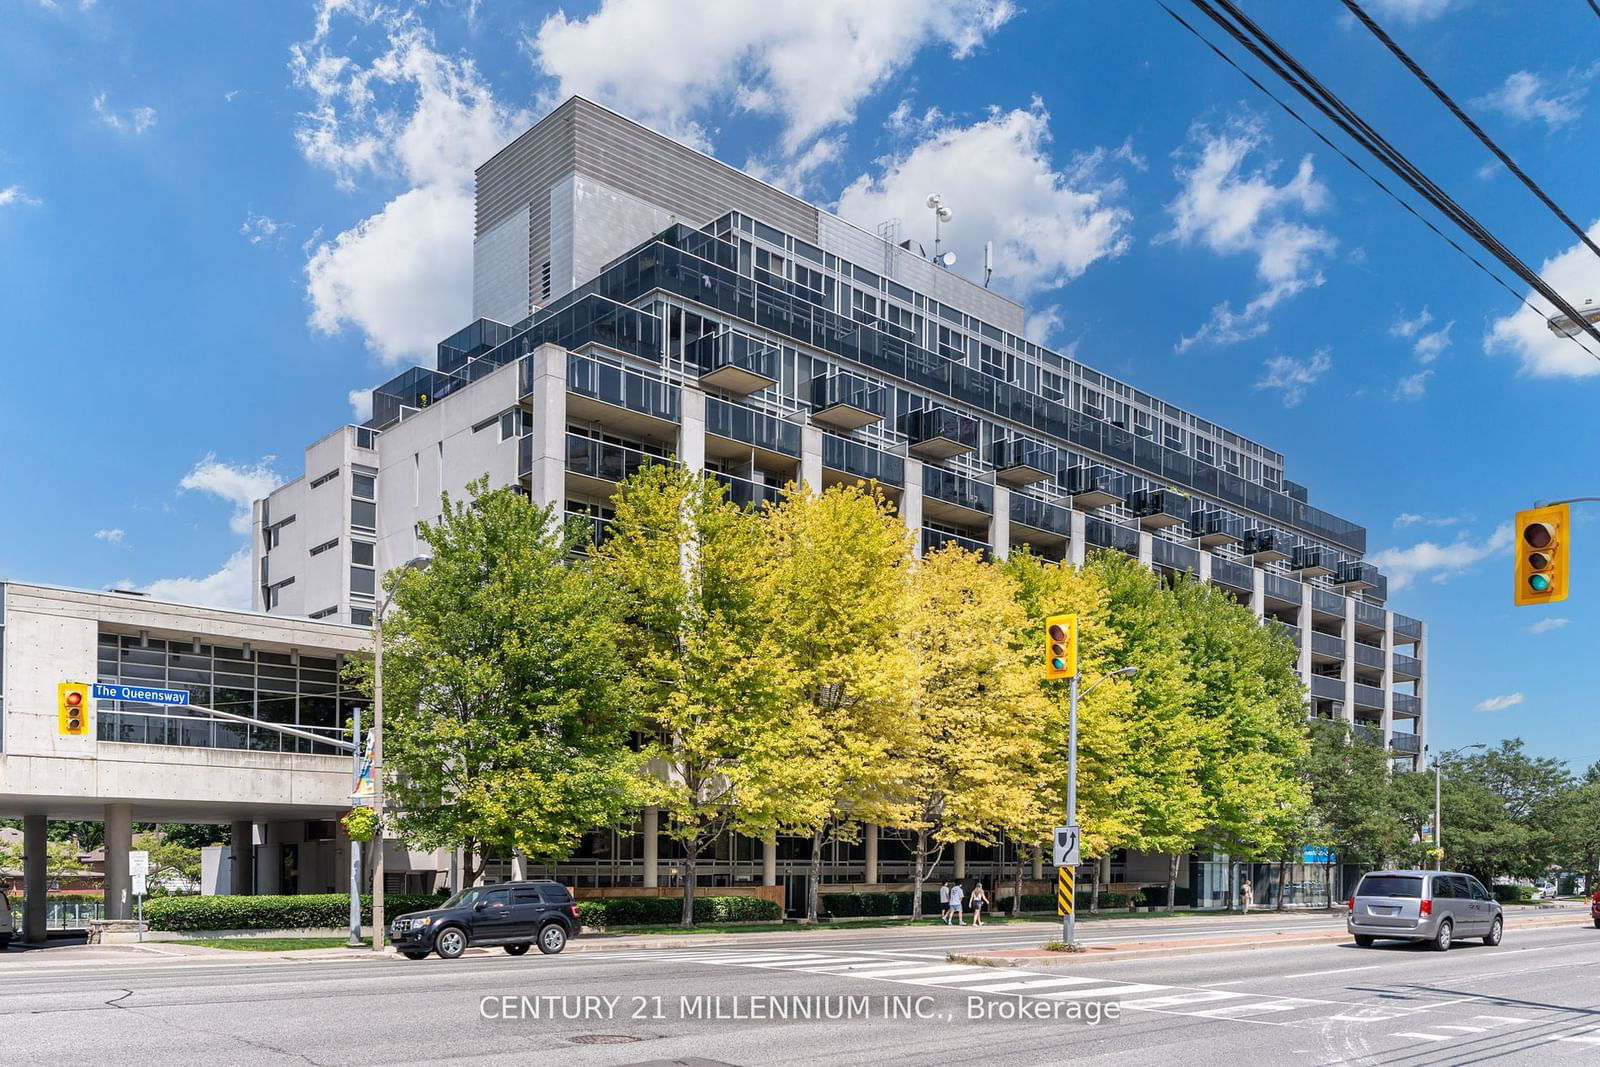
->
906, 545, 1059, 918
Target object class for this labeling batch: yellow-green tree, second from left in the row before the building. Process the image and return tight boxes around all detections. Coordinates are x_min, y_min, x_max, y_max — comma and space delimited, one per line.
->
603, 464, 784, 926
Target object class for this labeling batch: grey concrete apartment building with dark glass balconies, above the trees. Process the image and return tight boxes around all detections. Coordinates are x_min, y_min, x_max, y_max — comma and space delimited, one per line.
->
254, 98, 1426, 793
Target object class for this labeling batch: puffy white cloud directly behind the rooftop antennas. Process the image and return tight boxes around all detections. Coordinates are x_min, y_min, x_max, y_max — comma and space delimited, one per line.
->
837, 99, 1131, 299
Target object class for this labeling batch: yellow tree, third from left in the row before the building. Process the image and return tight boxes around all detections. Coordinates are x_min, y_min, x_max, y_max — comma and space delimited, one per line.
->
760, 486, 915, 921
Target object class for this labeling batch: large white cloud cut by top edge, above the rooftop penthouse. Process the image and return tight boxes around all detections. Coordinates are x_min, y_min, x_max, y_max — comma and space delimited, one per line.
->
526, 0, 1016, 157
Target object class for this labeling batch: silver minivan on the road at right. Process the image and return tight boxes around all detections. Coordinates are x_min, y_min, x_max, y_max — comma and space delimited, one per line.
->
1344, 870, 1506, 952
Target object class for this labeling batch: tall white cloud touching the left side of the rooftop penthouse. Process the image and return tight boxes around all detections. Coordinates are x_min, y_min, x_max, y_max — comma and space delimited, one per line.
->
290, 0, 531, 363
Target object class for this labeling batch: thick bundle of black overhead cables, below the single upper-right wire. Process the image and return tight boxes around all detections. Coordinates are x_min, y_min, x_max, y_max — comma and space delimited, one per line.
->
1190, 0, 1600, 358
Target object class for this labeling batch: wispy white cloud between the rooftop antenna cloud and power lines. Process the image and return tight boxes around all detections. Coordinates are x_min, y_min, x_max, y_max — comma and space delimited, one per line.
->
1157, 118, 1336, 352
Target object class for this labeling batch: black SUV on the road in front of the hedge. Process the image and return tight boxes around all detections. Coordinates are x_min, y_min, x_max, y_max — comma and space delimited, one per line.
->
389, 881, 582, 960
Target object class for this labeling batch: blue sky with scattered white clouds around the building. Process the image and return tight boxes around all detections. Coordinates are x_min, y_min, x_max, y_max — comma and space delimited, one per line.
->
0, 0, 1600, 766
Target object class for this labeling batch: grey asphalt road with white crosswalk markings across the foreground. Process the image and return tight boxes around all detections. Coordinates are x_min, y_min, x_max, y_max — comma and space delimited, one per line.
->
0, 917, 1600, 1067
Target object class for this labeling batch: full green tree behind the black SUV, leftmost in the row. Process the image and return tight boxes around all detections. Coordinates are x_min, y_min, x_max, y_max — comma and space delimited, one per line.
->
355, 480, 640, 881
